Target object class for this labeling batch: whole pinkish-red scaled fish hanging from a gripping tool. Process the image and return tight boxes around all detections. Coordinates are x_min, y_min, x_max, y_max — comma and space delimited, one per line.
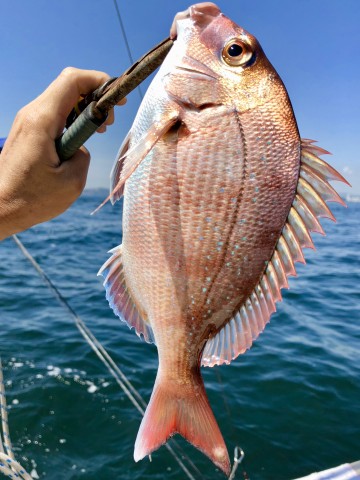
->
99, 2, 348, 475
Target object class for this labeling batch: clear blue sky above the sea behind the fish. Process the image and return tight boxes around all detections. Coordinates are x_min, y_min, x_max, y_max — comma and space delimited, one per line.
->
0, 0, 360, 194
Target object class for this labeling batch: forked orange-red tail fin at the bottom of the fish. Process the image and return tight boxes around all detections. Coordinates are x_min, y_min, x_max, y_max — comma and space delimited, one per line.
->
134, 375, 230, 475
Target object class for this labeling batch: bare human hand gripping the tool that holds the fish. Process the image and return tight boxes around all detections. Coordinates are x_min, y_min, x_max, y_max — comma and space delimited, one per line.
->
0, 68, 125, 240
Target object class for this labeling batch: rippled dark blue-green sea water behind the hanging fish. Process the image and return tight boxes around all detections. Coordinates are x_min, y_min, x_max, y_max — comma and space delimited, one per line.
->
0, 191, 360, 480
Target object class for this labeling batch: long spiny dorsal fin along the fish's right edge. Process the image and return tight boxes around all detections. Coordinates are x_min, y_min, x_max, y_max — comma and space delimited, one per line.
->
201, 140, 349, 367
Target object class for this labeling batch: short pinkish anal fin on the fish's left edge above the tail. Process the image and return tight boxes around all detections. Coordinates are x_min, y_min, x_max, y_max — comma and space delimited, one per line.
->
98, 245, 155, 343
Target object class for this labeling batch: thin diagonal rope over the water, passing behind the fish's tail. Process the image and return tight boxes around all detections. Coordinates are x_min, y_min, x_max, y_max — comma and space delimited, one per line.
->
12, 235, 201, 480
